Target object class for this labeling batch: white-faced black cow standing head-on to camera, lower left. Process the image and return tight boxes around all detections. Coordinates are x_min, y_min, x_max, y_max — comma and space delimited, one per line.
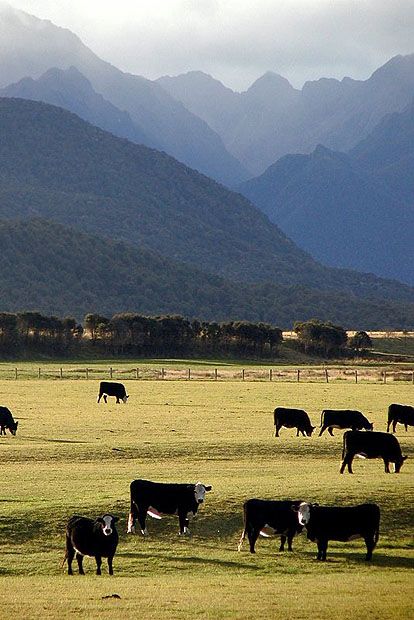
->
63, 514, 118, 575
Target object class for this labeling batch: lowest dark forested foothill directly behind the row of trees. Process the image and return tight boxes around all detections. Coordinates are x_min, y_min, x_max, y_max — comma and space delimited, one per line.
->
0, 219, 414, 329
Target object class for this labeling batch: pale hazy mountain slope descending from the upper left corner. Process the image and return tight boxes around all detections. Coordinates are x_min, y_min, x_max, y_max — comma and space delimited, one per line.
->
0, 4, 248, 184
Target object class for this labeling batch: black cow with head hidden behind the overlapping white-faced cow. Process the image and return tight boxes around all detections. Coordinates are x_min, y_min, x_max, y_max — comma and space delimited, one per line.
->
238, 499, 302, 553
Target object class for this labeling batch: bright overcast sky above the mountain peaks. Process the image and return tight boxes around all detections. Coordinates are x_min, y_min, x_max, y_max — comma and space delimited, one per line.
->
5, 0, 414, 90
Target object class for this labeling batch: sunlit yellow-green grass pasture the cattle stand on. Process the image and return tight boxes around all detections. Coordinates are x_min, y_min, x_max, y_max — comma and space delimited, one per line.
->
0, 379, 414, 620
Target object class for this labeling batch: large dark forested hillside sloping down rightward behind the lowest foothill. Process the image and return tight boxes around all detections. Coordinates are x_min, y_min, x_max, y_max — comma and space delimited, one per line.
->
0, 98, 414, 310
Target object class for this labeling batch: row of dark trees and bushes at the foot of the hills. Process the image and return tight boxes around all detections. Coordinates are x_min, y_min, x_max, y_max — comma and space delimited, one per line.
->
0, 311, 371, 359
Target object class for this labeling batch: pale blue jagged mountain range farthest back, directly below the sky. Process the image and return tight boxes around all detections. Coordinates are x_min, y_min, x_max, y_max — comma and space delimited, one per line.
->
158, 54, 414, 174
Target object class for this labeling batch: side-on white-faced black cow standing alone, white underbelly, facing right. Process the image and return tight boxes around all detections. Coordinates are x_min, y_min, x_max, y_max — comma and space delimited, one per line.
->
128, 480, 211, 536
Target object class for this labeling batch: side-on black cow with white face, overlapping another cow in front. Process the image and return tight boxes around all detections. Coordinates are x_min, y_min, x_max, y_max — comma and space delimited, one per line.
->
297, 502, 380, 562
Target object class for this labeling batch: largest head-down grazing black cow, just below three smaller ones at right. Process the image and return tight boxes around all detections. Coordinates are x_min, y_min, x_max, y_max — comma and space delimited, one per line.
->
339, 431, 407, 474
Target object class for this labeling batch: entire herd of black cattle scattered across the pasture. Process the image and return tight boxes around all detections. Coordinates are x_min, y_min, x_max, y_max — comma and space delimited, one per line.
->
0, 381, 414, 575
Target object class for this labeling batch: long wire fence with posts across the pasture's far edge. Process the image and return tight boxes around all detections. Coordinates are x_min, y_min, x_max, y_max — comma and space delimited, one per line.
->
0, 366, 414, 384
